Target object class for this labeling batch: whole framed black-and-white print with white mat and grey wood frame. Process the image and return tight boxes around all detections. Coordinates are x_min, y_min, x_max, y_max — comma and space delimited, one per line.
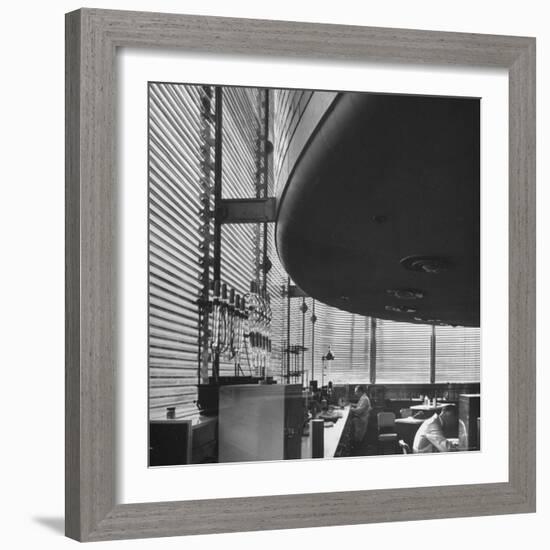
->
66, 9, 535, 540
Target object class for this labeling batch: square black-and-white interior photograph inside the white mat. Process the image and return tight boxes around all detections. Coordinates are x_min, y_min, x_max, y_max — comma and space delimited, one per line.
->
147, 82, 482, 467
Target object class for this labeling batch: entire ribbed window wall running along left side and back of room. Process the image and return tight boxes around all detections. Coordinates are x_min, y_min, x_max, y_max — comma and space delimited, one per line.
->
149, 83, 479, 418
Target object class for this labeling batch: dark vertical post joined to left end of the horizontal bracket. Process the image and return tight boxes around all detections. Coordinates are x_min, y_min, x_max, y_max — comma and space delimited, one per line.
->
212, 86, 223, 380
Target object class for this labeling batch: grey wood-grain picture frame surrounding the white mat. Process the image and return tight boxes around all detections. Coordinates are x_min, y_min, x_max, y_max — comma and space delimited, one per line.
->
66, 9, 535, 541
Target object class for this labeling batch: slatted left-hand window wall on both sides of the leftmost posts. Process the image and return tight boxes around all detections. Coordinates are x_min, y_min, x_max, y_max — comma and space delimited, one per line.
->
149, 84, 263, 419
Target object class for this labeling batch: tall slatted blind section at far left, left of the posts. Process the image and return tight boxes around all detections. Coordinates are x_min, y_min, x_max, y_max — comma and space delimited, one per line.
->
148, 84, 214, 419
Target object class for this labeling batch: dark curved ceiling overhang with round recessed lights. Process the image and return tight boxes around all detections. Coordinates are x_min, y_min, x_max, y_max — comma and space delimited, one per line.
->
276, 93, 480, 326
